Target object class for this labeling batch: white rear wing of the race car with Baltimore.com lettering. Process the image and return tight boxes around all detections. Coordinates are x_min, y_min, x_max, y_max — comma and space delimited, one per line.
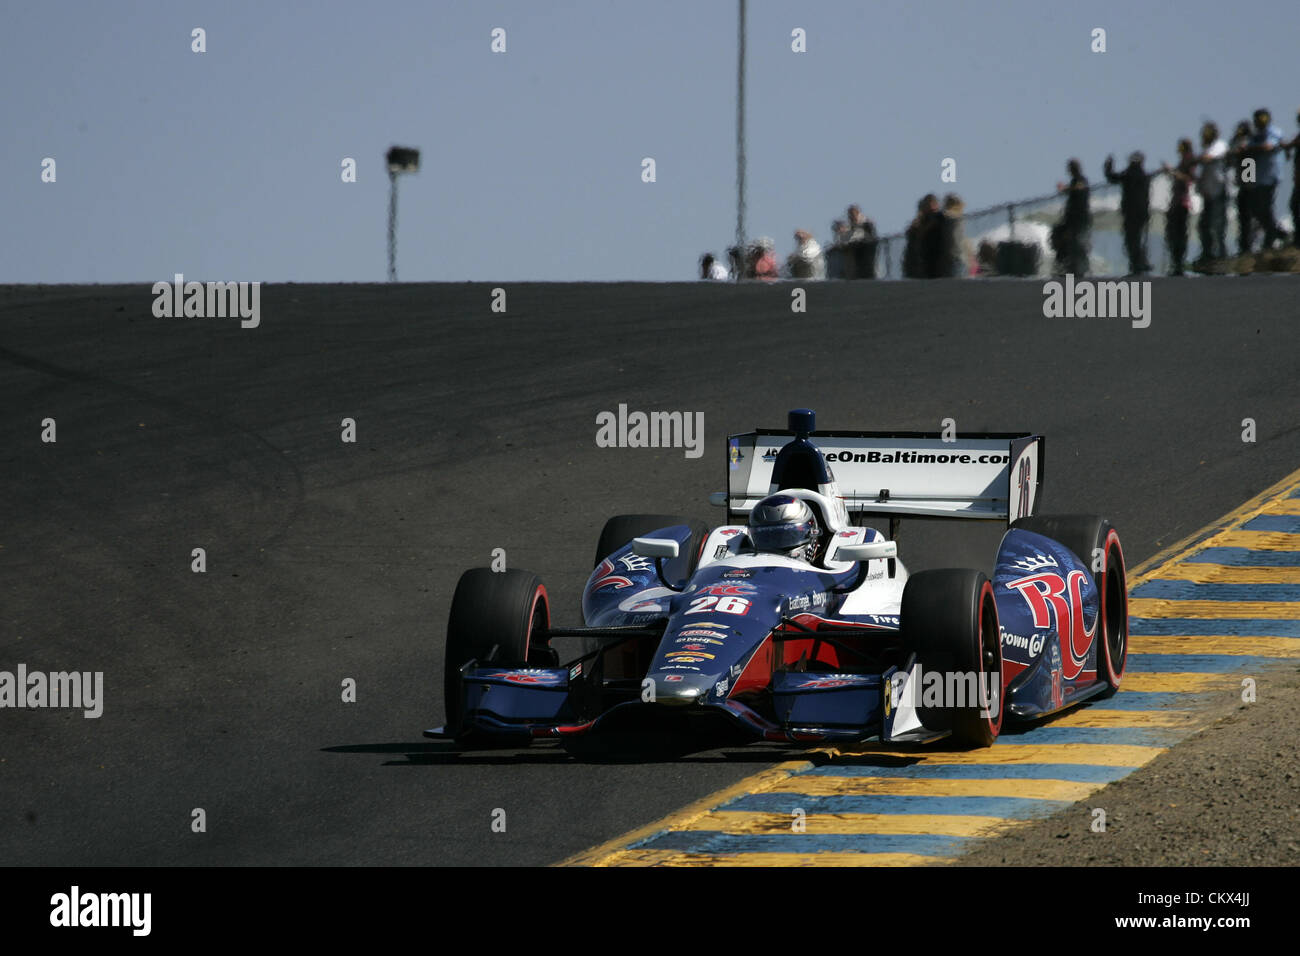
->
714, 428, 1044, 524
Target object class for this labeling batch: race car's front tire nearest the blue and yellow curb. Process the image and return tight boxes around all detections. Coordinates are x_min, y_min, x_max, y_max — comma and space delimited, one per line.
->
901, 568, 1004, 747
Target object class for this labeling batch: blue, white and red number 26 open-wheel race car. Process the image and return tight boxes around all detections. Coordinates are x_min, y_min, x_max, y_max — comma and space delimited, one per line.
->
425, 408, 1128, 747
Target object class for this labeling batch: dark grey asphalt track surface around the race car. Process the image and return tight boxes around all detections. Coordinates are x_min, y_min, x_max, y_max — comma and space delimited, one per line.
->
0, 277, 1300, 865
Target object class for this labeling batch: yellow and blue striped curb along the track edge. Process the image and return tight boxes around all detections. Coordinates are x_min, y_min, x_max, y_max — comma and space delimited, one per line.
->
560, 471, 1300, 866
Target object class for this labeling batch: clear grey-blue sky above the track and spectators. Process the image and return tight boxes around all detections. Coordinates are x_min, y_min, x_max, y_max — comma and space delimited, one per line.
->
0, 0, 1300, 282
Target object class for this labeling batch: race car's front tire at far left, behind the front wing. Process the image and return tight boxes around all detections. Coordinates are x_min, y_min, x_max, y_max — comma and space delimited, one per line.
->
442, 567, 556, 732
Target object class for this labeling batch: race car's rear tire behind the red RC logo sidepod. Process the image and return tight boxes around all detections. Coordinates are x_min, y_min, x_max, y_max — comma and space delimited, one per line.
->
1011, 515, 1128, 698
